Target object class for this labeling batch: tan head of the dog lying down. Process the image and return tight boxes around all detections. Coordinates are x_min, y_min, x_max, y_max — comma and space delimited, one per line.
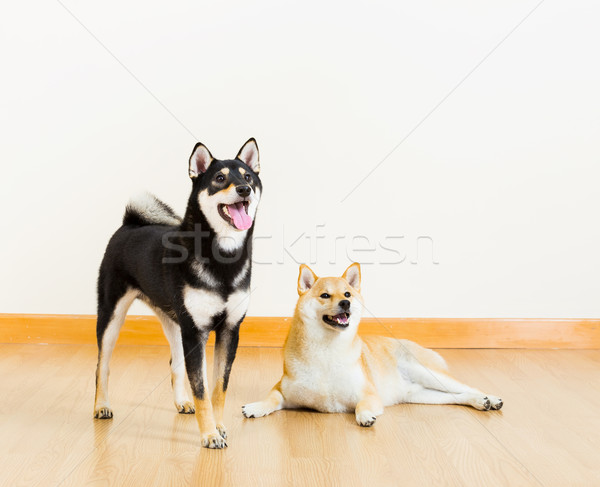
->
298, 263, 363, 332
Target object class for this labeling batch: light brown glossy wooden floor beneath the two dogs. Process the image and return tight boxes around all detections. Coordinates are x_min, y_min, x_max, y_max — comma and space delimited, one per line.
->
0, 344, 600, 487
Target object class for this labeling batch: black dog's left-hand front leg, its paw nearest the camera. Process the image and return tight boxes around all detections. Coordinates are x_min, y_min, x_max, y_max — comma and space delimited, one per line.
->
179, 324, 227, 448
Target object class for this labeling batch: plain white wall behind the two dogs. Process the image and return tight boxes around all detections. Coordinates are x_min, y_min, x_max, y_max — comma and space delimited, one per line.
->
0, 0, 600, 318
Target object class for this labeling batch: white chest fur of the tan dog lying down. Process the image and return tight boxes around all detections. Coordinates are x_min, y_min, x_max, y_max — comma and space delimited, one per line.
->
281, 347, 365, 413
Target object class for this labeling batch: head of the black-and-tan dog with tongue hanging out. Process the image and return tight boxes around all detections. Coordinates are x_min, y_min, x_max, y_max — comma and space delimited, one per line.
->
189, 139, 262, 250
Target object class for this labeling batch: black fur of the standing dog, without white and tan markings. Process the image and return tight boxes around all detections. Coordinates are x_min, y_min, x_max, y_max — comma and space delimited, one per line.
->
96, 139, 262, 444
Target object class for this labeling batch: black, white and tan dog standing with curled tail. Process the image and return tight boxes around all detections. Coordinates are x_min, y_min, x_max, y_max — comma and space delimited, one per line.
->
94, 139, 262, 448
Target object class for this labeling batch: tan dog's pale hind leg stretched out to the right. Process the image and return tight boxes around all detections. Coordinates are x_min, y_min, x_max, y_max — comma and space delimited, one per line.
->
411, 365, 503, 410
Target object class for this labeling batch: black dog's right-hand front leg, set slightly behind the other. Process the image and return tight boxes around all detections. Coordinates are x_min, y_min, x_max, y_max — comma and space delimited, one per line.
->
212, 324, 240, 438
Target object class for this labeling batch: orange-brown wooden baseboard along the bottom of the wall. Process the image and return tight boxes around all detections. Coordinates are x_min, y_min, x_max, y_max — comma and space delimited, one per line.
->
0, 314, 600, 349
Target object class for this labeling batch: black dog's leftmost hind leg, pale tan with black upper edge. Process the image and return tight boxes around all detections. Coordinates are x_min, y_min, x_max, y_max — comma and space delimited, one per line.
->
94, 290, 137, 419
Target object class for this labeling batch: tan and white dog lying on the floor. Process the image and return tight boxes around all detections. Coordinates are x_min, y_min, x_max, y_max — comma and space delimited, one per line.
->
243, 264, 502, 426
